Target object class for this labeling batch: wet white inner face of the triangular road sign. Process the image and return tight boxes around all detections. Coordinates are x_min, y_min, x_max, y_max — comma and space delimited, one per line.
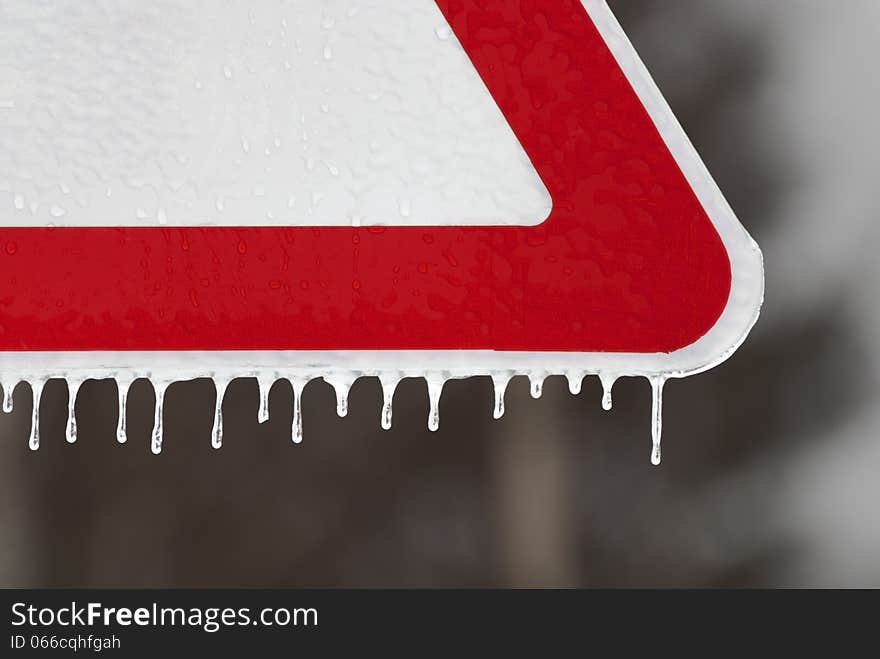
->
0, 0, 551, 226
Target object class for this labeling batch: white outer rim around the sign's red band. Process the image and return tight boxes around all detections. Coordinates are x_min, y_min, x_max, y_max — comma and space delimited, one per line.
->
0, 0, 764, 388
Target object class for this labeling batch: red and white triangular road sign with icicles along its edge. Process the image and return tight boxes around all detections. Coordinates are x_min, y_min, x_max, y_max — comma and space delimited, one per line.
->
0, 0, 763, 460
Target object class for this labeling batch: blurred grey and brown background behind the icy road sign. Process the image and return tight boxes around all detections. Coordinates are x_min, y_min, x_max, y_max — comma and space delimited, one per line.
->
0, 0, 880, 587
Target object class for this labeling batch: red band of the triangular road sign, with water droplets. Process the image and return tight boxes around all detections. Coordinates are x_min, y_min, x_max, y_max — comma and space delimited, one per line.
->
0, 0, 759, 357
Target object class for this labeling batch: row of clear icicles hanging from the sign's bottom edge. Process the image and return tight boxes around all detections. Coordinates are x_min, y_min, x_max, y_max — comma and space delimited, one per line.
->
2, 375, 665, 465
